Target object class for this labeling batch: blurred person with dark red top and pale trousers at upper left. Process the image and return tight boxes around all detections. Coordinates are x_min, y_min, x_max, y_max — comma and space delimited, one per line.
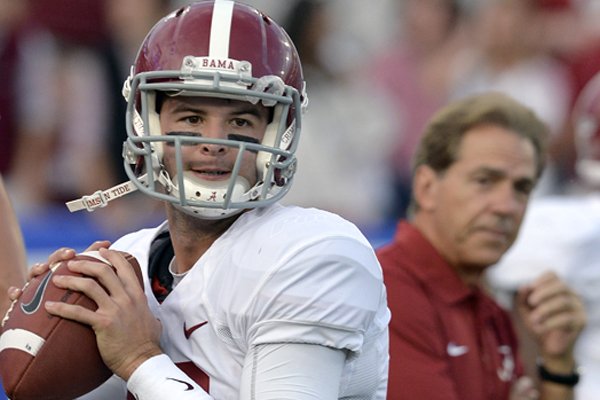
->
5, 0, 106, 215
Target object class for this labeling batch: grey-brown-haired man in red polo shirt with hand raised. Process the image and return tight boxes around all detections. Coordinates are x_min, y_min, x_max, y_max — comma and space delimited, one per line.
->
377, 93, 585, 400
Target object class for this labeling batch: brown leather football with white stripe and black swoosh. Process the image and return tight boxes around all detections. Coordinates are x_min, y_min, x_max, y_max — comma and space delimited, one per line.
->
0, 251, 143, 400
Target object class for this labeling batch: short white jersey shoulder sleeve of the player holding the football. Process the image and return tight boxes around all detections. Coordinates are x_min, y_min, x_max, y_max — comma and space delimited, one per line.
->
240, 237, 385, 352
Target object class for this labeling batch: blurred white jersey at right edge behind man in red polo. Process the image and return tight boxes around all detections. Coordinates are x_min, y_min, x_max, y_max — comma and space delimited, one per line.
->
488, 194, 600, 400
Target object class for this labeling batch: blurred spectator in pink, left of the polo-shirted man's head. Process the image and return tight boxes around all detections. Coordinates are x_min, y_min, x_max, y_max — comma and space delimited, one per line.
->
370, 0, 466, 219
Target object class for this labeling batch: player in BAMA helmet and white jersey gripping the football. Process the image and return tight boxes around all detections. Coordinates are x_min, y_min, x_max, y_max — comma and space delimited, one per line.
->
12, 0, 390, 400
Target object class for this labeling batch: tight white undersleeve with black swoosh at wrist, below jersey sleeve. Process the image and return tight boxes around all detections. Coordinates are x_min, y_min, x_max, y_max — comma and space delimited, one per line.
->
127, 344, 344, 400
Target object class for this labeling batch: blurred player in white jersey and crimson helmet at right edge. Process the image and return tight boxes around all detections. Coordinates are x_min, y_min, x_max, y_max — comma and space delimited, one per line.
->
488, 69, 600, 400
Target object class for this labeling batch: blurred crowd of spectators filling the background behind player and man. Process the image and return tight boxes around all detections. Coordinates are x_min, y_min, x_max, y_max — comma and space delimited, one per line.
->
0, 0, 600, 234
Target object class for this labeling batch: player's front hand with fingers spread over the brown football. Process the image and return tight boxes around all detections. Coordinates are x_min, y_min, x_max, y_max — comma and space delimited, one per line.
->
45, 248, 162, 380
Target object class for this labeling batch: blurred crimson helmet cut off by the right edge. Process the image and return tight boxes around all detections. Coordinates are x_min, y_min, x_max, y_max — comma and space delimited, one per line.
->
573, 72, 600, 187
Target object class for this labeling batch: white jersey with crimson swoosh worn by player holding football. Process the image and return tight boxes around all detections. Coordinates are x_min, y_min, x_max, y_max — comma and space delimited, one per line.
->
100, 205, 390, 400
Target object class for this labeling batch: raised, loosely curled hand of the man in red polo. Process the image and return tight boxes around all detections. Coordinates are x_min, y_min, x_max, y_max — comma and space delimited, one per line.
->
517, 272, 586, 371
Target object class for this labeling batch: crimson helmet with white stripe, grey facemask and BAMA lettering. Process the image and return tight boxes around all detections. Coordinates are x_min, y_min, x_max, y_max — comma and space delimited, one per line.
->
116, 0, 308, 219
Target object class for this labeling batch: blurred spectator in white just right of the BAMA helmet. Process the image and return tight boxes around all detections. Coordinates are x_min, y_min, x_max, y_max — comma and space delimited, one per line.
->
283, 0, 395, 229
